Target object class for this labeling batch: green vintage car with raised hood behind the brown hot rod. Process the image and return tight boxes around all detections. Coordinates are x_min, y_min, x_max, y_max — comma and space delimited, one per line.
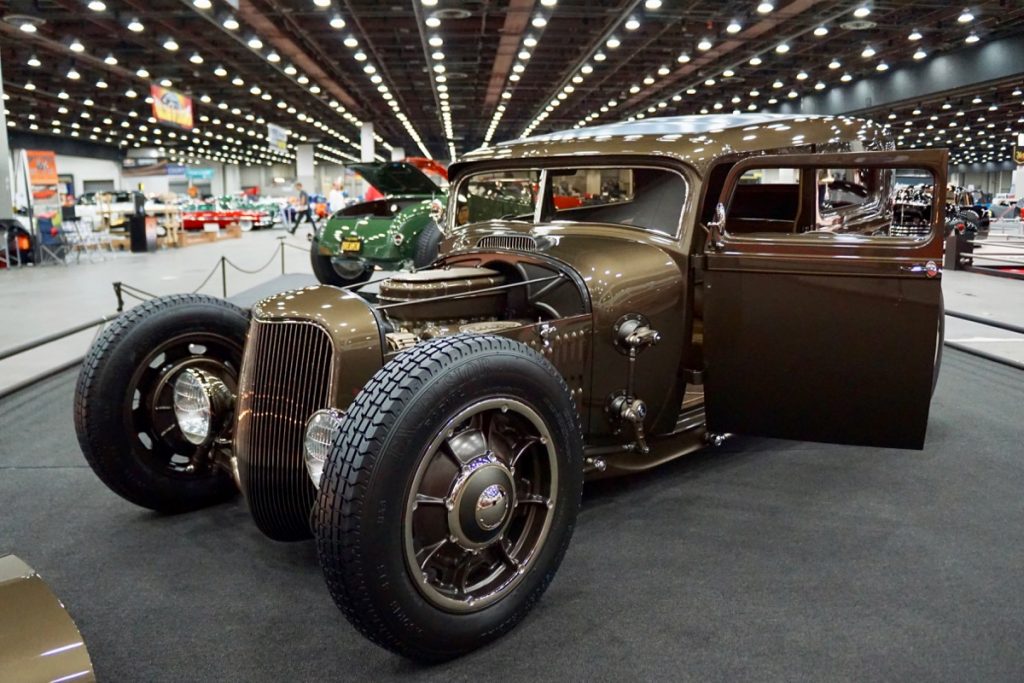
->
309, 159, 447, 287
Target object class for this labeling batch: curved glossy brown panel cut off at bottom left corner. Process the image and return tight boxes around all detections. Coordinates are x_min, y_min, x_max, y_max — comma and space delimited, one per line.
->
0, 555, 96, 683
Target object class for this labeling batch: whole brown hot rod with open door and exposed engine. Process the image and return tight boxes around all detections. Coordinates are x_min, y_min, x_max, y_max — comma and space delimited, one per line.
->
76, 115, 947, 659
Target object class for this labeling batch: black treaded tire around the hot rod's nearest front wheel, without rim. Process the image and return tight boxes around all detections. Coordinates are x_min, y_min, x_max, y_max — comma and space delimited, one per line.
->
313, 335, 583, 661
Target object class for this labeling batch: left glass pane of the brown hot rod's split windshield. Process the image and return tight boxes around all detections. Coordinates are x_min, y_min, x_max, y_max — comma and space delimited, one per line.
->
455, 169, 541, 225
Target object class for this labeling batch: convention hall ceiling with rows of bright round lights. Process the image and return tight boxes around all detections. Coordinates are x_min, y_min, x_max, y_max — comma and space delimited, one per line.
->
0, 0, 1024, 163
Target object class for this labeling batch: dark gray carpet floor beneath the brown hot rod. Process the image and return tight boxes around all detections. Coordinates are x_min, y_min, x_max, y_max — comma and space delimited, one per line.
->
0, 350, 1024, 681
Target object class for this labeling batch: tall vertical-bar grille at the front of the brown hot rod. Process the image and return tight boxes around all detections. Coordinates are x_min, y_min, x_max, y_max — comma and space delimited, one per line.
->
236, 321, 334, 541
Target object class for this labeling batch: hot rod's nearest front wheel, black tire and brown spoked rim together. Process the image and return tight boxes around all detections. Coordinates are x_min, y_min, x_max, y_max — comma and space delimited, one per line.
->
314, 336, 583, 660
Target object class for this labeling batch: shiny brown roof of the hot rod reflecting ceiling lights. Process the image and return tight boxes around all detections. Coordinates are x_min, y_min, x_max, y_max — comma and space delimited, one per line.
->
450, 114, 891, 175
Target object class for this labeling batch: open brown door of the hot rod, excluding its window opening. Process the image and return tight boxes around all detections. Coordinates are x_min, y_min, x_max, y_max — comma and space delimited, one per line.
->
703, 151, 947, 449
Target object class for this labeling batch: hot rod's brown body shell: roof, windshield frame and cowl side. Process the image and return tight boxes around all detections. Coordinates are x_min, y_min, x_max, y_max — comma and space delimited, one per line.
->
442, 117, 888, 444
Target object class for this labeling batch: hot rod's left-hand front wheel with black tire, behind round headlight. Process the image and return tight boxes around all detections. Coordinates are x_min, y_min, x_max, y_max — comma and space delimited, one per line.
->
75, 294, 249, 512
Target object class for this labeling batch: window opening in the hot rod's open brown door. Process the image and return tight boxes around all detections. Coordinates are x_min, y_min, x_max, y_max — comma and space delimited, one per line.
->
725, 166, 934, 240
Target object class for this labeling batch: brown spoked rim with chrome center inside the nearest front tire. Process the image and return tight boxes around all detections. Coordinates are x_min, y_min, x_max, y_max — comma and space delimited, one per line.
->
404, 398, 558, 612
